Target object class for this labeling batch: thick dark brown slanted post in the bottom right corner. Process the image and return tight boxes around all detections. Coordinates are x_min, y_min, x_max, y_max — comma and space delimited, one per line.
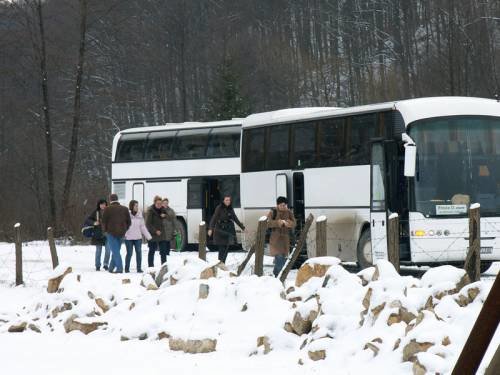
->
451, 274, 500, 375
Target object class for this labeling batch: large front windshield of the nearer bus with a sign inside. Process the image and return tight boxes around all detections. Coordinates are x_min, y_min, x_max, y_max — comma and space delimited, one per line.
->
409, 116, 500, 217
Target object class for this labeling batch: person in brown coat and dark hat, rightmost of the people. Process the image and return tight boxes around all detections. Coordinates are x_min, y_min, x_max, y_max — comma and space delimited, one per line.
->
267, 197, 296, 276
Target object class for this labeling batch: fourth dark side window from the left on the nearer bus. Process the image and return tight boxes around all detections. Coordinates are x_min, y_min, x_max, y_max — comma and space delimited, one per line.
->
318, 118, 346, 167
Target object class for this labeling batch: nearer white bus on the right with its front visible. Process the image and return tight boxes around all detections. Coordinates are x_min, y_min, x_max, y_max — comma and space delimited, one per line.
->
241, 97, 500, 267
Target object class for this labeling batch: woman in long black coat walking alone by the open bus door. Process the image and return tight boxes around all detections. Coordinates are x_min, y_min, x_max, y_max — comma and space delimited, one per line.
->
208, 195, 245, 263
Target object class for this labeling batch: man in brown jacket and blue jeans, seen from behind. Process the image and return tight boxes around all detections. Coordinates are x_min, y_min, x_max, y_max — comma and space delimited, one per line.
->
102, 194, 132, 273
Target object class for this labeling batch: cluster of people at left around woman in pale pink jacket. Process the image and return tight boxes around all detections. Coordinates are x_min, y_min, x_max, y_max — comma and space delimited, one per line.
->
85, 194, 180, 273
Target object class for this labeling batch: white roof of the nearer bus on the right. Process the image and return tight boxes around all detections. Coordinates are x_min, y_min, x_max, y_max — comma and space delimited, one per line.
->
243, 96, 500, 128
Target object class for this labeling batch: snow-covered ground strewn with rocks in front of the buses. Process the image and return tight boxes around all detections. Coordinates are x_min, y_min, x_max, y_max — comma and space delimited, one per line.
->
0, 242, 500, 375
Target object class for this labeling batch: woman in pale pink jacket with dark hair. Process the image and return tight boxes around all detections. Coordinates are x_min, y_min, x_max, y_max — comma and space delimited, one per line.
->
125, 200, 151, 272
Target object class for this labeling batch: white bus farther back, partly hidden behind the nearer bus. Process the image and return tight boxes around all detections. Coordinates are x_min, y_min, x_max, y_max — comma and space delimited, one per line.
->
111, 120, 241, 247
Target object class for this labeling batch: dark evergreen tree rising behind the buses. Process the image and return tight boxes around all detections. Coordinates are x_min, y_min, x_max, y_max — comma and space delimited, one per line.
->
206, 58, 250, 121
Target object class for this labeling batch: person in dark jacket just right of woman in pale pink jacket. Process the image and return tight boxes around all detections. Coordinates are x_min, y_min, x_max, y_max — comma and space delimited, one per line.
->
146, 196, 171, 267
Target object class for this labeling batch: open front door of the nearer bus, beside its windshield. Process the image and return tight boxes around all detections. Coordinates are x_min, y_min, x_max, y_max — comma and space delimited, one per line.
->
370, 141, 388, 264
